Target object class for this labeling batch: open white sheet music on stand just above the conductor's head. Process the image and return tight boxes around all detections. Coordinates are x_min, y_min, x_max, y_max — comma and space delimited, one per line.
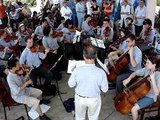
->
90, 37, 106, 49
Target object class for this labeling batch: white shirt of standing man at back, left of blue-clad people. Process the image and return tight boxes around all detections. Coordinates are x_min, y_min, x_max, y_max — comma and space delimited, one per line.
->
60, 6, 72, 20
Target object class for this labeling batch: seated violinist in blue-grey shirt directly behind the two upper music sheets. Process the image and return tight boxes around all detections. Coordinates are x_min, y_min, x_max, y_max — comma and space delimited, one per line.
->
82, 15, 94, 37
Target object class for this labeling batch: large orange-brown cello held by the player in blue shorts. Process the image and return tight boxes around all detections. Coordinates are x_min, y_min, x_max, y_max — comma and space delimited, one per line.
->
114, 74, 151, 114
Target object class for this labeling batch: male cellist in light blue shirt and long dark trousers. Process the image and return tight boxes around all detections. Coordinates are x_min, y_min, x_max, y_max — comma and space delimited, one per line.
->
116, 34, 142, 94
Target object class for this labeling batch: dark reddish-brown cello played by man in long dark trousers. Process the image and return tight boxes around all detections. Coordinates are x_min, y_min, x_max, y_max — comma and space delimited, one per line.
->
107, 50, 130, 83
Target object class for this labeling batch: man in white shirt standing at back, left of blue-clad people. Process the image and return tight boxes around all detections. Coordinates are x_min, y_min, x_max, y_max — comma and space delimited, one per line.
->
60, 2, 72, 20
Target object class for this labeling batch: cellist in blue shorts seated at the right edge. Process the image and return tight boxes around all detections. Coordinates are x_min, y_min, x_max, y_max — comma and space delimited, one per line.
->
123, 57, 160, 120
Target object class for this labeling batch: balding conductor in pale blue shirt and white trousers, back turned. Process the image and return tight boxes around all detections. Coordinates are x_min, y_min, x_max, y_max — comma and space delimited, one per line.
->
68, 46, 108, 120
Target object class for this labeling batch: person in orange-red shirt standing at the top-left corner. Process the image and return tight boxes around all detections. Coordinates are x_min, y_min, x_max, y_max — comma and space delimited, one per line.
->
0, 0, 8, 29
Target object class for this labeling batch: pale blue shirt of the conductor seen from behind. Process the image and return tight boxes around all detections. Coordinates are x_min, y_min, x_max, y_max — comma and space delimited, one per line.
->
68, 64, 108, 97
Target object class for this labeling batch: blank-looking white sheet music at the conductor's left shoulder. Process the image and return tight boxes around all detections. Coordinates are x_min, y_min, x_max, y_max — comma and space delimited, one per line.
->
67, 60, 85, 73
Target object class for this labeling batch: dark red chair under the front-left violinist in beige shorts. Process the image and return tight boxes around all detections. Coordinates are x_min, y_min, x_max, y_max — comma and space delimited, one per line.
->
0, 80, 30, 120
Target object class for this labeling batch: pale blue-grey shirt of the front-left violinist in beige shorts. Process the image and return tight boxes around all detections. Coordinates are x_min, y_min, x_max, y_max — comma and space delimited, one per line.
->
7, 72, 29, 103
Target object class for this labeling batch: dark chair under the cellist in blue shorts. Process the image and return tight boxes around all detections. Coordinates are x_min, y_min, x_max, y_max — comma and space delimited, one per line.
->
140, 98, 160, 120
